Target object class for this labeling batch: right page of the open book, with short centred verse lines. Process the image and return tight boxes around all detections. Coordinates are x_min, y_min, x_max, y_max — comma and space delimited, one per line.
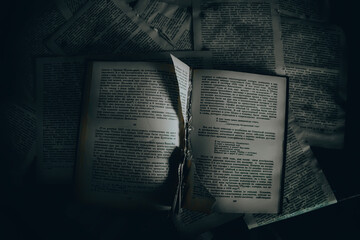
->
189, 70, 287, 213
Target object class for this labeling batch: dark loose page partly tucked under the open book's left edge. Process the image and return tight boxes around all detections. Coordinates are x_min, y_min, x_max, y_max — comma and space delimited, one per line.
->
36, 57, 85, 184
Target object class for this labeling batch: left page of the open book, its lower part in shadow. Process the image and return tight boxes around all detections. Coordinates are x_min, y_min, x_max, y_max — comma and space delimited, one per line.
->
76, 62, 180, 209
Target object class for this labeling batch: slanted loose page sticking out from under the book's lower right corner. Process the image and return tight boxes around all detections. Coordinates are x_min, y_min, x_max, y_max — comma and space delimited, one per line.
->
244, 114, 336, 228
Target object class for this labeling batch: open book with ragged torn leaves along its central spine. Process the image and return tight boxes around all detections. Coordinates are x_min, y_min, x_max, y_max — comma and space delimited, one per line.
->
76, 56, 287, 213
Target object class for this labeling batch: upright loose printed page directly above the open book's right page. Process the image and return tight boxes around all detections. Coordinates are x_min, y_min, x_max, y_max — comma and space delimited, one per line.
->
193, 0, 284, 75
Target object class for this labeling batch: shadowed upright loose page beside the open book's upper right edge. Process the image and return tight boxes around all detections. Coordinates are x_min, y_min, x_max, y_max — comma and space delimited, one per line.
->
281, 17, 347, 148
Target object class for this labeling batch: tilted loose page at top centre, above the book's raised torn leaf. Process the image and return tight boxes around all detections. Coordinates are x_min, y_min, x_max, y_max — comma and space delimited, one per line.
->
134, 0, 193, 50
